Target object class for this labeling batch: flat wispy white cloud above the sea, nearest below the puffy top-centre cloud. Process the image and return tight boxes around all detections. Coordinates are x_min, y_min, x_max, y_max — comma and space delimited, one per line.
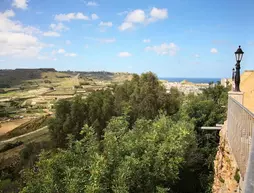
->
145, 43, 179, 56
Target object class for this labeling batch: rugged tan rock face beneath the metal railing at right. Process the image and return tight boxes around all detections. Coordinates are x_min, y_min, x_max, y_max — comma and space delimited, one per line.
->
213, 122, 241, 193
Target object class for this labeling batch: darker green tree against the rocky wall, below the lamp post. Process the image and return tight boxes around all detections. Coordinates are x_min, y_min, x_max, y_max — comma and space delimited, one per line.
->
174, 84, 229, 193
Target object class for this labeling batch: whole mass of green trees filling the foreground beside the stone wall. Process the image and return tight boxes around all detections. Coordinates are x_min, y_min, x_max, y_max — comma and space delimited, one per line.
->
0, 73, 228, 193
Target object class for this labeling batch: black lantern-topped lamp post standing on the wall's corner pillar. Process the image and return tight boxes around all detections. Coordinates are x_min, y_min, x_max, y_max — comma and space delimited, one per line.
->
235, 46, 244, 92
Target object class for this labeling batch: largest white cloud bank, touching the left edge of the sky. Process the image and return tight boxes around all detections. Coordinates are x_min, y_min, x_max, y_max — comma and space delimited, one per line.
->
0, 10, 49, 57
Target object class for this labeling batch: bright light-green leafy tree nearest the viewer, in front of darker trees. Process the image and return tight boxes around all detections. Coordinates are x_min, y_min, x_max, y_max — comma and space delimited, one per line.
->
22, 116, 195, 193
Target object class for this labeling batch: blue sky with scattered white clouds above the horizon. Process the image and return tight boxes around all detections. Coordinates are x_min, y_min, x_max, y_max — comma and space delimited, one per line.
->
0, 0, 254, 78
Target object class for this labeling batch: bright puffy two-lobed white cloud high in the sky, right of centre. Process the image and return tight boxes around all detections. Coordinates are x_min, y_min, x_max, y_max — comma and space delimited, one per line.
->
119, 7, 168, 31
